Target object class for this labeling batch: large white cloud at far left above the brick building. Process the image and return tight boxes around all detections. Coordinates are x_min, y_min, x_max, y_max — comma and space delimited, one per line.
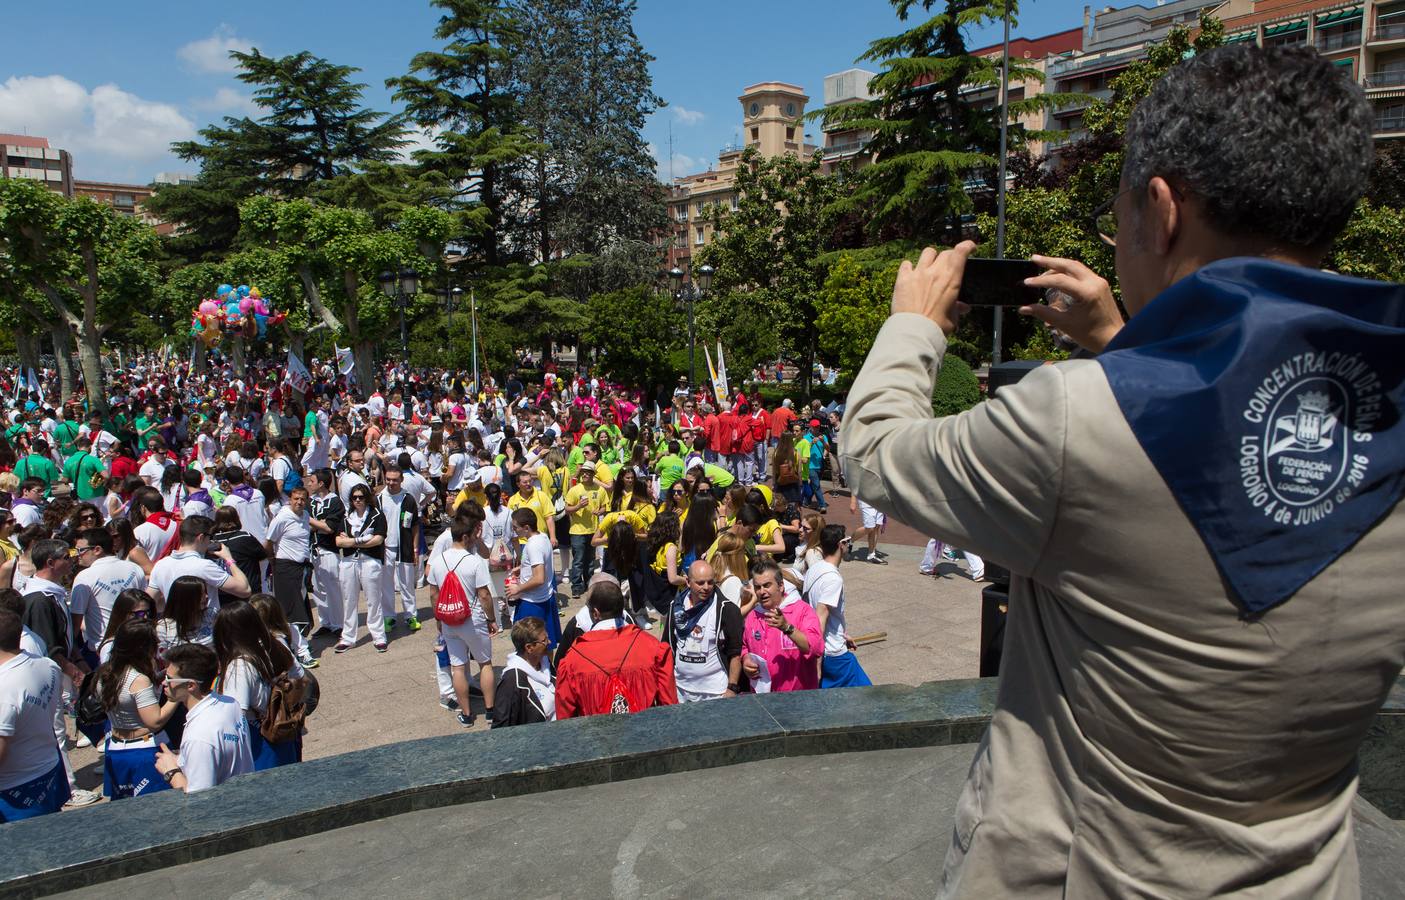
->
0, 74, 195, 180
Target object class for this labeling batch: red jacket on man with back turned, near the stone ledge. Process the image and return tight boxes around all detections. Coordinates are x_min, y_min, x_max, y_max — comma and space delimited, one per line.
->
556, 625, 679, 719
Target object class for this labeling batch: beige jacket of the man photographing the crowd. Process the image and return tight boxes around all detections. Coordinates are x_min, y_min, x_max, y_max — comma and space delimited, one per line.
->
842, 313, 1405, 900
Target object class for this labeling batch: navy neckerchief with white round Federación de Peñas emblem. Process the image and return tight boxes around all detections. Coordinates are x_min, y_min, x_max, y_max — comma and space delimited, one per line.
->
1097, 258, 1405, 614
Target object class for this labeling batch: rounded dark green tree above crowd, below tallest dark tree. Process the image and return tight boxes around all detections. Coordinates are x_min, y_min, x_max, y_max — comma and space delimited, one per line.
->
582, 285, 684, 386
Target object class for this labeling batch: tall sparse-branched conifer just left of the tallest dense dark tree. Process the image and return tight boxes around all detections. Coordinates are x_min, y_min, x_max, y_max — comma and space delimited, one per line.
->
385, 0, 537, 265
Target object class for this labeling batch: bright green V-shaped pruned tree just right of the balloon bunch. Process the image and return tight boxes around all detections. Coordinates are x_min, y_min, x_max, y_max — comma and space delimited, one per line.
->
240, 197, 452, 392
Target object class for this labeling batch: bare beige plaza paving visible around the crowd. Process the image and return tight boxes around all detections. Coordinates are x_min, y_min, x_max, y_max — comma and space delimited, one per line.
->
70, 494, 984, 789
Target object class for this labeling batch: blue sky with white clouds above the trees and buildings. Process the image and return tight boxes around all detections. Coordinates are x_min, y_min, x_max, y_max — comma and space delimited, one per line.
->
0, 0, 1083, 184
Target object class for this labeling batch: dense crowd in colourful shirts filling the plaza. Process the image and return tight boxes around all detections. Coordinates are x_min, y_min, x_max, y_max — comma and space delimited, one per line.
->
0, 357, 910, 821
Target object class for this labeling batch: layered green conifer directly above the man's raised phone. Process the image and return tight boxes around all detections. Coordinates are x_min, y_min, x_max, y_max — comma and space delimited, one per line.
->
813, 0, 1073, 243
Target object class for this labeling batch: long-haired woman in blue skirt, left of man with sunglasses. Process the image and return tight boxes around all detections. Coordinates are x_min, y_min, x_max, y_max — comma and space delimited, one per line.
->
93, 619, 180, 800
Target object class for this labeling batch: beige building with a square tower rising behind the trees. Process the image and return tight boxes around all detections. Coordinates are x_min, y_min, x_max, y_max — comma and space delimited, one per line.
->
665, 81, 816, 271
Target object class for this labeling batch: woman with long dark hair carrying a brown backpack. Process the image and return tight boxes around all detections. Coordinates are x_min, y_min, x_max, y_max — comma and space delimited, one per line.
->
215, 604, 302, 772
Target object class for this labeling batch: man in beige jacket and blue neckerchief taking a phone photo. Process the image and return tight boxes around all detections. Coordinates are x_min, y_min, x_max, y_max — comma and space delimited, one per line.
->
844, 45, 1405, 897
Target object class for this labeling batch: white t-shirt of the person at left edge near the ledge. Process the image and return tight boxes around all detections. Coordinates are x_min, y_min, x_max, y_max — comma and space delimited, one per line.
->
0, 653, 62, 790
